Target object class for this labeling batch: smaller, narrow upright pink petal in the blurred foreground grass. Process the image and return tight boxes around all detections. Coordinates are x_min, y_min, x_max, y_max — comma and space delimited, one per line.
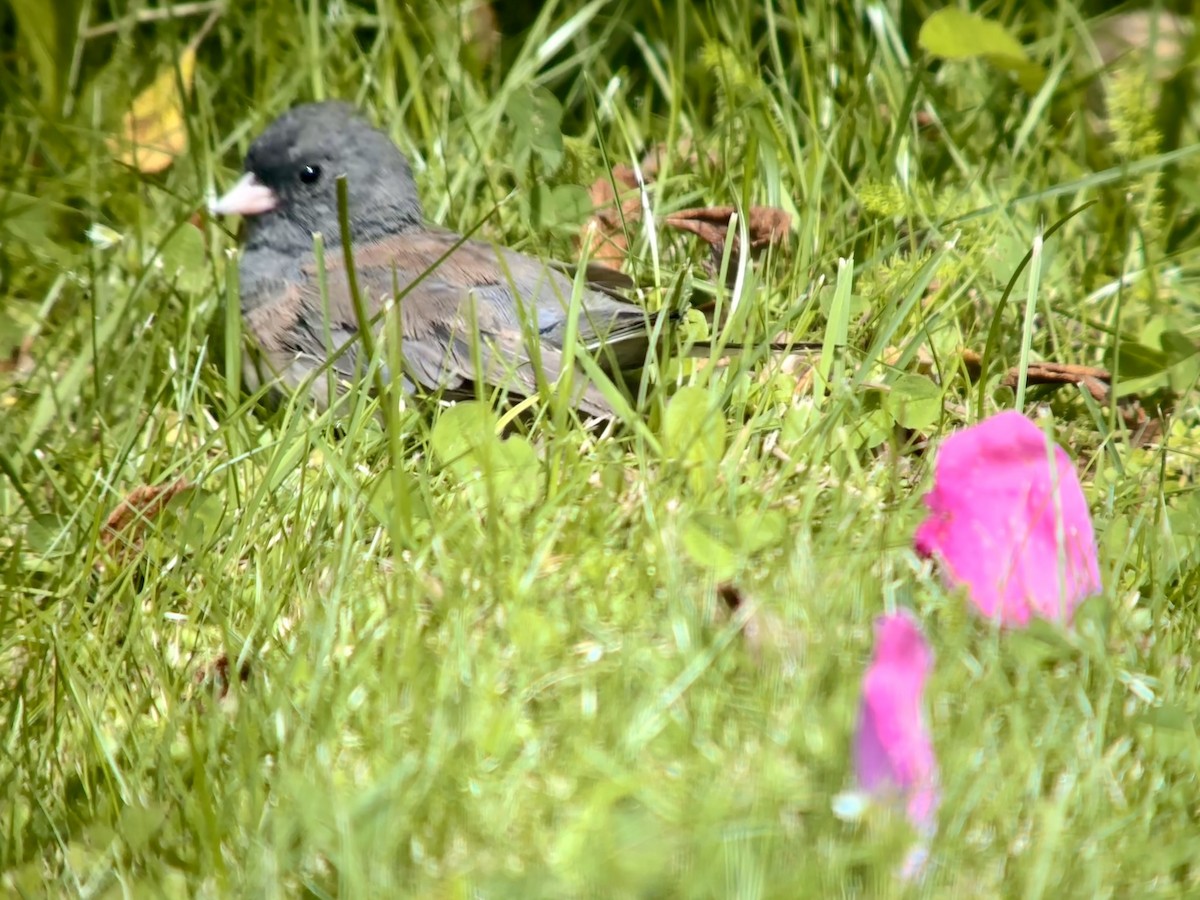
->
854, 612, 938, 834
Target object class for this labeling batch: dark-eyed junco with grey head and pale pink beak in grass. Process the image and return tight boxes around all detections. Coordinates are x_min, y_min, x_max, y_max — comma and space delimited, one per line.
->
211, 102, 796, 416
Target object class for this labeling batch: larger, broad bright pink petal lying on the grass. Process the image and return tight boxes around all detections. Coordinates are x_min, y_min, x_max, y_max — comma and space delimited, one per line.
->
914, 412, 1100, 626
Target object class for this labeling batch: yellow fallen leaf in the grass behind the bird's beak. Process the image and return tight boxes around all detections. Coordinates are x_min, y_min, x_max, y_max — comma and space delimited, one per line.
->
109, 46, 196, 174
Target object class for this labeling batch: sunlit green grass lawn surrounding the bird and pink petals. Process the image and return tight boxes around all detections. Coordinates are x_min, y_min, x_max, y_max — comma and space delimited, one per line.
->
0, 0, 1200, 898
